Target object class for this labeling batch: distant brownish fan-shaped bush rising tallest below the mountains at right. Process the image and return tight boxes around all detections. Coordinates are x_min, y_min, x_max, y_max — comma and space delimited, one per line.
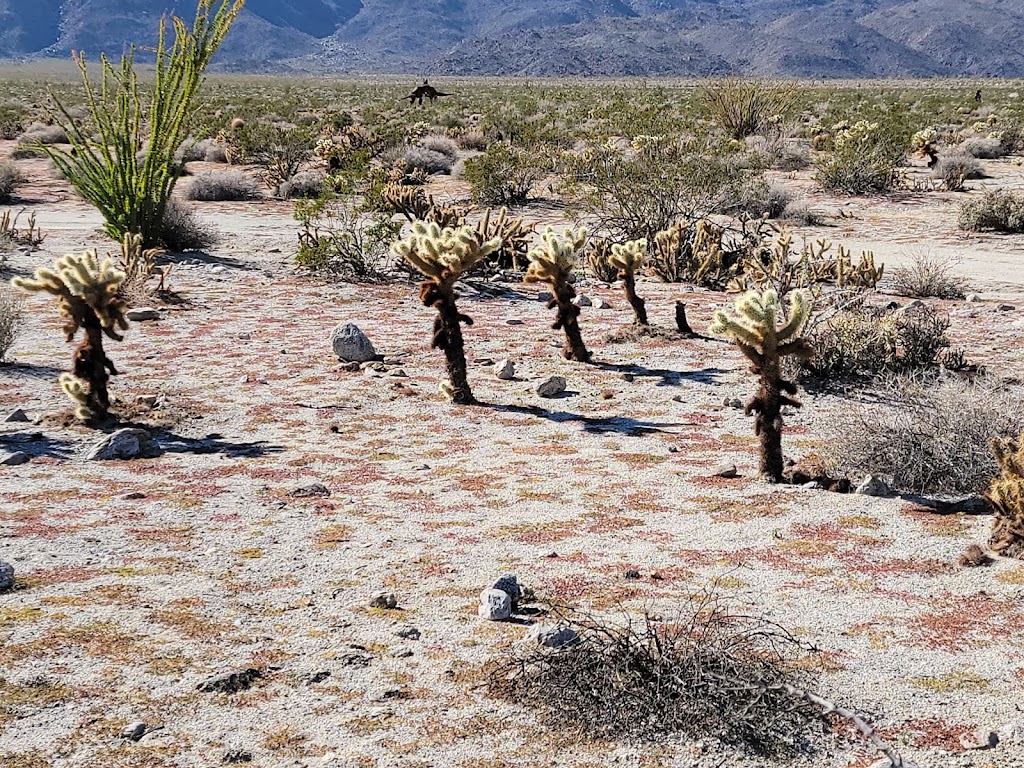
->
700, 78, 798, 139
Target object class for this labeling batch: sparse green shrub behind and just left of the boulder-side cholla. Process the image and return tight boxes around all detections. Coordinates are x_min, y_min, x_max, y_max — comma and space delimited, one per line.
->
295, 190, 401, 283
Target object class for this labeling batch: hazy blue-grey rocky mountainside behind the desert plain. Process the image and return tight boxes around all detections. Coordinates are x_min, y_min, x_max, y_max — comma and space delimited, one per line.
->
0, 0, 1024, 77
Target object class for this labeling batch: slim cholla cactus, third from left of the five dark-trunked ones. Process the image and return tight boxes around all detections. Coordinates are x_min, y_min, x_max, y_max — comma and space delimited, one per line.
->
524, 226, 590, 362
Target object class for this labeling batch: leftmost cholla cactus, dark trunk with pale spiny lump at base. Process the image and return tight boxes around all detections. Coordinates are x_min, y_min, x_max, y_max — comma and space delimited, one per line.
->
11, 251, 128, 421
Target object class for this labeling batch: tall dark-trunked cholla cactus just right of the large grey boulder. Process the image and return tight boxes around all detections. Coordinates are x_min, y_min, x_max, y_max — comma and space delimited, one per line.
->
394, 221, 502, 403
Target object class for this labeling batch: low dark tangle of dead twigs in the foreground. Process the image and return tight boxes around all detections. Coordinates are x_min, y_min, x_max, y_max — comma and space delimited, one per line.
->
487, 592, 904, 766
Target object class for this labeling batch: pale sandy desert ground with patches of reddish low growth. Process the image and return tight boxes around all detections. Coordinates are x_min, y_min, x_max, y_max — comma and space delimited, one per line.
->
0, 75, 1024, 768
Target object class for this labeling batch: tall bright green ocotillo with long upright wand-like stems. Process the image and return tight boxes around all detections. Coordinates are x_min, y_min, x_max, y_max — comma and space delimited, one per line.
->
36, 0, 243, 247
